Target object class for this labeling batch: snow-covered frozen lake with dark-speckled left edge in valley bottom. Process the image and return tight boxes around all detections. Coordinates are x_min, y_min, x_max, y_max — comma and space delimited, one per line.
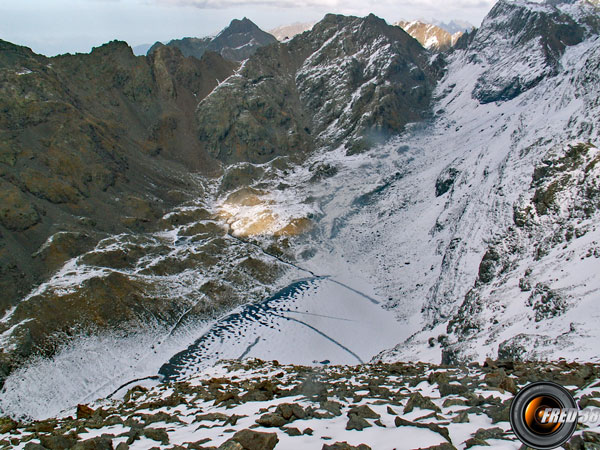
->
160, 277, 407, 380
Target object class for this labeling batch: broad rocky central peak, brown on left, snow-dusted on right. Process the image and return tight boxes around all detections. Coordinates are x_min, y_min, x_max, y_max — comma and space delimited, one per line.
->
198, 14, 437, 162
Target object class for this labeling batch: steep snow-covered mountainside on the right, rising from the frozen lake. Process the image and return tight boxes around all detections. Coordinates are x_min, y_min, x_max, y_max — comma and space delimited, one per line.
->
152, 2, 600, 382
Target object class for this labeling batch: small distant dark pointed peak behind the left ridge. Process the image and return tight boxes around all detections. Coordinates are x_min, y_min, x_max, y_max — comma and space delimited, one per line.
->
148, 17, 277, 61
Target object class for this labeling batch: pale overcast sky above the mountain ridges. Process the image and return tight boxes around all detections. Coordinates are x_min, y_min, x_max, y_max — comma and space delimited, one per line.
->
0, 0, 494, 55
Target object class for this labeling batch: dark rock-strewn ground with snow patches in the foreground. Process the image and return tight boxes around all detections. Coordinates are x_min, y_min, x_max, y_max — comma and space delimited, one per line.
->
0, 359, 600, 450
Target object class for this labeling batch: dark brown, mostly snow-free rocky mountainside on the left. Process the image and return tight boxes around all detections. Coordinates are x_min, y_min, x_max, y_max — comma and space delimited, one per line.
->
0, 42, 244, 386
